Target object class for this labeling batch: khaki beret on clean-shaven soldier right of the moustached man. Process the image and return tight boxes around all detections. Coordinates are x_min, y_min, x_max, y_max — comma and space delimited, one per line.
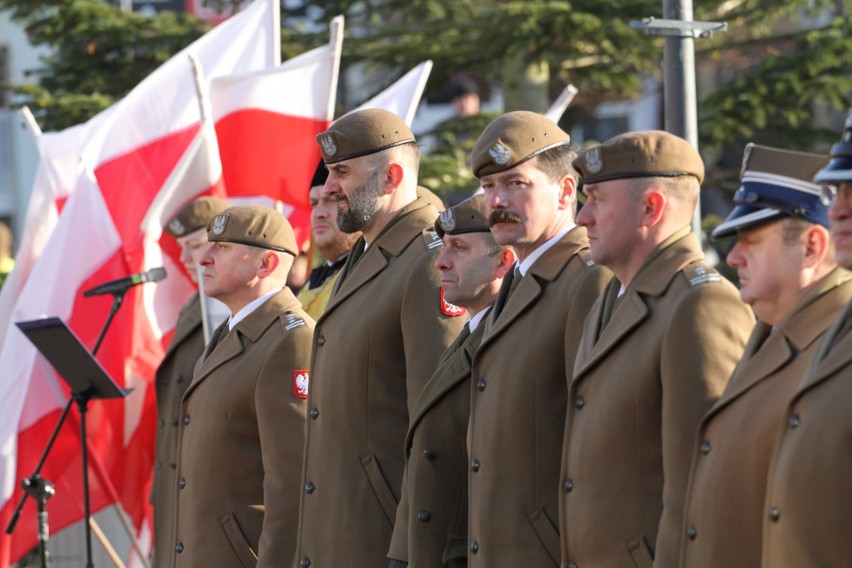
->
573, 130, 704, 183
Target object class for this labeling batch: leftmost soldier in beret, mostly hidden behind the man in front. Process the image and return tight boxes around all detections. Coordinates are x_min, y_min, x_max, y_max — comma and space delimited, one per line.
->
151, 197, 228, 566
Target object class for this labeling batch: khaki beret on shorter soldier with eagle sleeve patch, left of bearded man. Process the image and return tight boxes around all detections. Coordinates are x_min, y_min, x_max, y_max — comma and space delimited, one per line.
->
207, 205, 299, 256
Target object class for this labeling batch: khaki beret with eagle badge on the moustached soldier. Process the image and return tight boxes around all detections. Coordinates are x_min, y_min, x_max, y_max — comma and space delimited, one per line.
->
470, 110, 571, 178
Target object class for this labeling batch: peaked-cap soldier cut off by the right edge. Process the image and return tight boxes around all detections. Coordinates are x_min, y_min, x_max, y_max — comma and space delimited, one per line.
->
761, 114, 852, 568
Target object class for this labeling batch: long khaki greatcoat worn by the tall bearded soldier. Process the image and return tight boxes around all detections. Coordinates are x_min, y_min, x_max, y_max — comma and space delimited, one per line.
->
296, 198, 464, 568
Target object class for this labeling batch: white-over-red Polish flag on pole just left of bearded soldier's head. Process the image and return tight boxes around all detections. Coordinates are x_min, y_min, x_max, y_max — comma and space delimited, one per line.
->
210, 16, 343, 251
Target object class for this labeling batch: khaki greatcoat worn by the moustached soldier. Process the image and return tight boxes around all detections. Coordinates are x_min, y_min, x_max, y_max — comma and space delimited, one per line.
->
468, 227, 609, 568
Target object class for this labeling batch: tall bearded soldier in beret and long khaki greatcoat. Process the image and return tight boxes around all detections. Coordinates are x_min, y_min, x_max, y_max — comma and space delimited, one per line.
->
296, 109, 464, 568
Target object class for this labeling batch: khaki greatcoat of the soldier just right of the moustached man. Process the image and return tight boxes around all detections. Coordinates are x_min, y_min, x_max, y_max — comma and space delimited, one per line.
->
560, 227, 754, 568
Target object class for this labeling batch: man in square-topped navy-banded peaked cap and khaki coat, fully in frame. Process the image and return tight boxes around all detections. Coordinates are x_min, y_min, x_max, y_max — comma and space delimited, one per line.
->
677, 144, 852, 568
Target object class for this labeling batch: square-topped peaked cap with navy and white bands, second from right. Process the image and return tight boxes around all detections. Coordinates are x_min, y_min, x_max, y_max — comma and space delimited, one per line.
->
712, 144, 828, 239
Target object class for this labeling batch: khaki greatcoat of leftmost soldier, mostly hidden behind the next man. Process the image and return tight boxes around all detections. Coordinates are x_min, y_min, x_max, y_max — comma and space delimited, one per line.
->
151, 292, 204, 566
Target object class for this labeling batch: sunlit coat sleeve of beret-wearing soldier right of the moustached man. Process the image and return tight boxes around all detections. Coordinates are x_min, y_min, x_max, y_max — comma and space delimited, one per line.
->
654, 281, 754, 567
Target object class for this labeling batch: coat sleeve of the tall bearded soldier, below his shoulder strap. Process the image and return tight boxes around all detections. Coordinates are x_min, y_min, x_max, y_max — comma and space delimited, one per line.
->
400, 248, 467, 412
